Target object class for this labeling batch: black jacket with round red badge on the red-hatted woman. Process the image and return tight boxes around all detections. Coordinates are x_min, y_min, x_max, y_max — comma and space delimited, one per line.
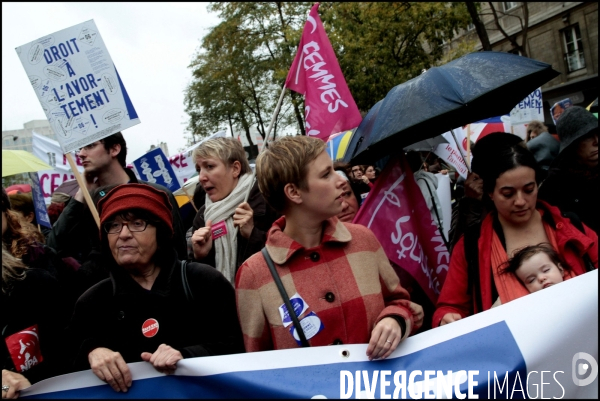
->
67, 247, 244, 370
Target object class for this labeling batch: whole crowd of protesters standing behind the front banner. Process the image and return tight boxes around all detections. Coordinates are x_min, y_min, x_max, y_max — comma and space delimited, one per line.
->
1, 106, 598, 398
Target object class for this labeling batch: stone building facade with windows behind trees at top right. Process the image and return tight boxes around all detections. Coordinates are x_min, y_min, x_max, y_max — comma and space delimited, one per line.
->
446, 2, 598, 123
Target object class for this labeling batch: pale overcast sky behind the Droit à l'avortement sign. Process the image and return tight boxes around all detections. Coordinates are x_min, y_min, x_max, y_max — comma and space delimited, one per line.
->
2, 2, 219, 162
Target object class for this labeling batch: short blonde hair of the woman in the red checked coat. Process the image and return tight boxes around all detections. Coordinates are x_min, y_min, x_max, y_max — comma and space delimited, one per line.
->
256, 136, 325, 212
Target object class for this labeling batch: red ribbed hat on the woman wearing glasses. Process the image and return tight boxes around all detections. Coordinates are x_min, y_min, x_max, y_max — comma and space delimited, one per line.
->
98, 184, 173, 236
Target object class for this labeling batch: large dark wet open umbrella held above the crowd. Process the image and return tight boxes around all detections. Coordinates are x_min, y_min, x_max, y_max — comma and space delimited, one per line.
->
344, 52, 560, 164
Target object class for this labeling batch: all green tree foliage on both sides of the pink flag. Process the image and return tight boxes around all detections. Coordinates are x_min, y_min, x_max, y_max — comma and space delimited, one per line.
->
185, 2, 470, 142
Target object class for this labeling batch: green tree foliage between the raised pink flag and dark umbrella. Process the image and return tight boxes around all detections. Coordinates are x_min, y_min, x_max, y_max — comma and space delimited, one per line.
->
320, 2, 470, 111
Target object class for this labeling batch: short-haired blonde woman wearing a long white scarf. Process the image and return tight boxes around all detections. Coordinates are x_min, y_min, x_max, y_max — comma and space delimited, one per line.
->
191, 138, 274, 284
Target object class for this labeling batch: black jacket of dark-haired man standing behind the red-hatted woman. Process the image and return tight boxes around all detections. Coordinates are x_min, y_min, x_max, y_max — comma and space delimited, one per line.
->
47, 169, 187, 299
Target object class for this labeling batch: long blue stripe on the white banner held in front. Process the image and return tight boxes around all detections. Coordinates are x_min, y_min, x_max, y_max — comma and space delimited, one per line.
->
24, 321, 527, 399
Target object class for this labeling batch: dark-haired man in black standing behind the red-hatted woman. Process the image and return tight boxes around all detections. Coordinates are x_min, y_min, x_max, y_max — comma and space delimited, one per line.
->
48, 132, 187, 290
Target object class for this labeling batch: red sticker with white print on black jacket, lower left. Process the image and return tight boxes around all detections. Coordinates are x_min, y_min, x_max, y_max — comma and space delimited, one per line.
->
4, 324, 44, 372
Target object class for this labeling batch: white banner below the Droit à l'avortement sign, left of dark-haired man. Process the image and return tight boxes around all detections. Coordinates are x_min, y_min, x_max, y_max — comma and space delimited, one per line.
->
31, 132, 83, 205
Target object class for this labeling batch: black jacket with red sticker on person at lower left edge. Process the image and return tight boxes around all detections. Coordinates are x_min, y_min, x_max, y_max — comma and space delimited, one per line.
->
0, 268, 69, 384
